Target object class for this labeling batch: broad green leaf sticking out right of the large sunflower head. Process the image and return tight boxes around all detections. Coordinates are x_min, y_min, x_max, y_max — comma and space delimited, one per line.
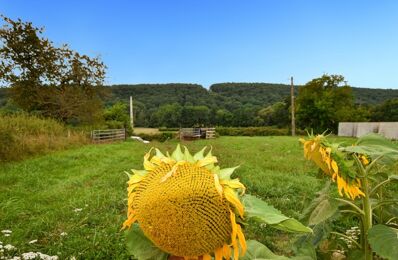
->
242, 195, 312, 233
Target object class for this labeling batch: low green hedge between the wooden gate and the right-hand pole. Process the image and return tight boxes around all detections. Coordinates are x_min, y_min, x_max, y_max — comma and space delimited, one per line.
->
216, 127, 290, 136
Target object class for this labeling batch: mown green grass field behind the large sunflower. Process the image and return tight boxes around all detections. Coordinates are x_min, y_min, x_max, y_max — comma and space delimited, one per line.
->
0, 137, 346, 259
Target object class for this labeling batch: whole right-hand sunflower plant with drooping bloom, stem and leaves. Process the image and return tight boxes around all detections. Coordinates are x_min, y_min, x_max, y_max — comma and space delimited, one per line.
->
304, 134, 398, 259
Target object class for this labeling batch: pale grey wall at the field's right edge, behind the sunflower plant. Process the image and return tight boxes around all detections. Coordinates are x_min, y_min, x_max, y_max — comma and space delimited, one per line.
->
338, 122, 398, 140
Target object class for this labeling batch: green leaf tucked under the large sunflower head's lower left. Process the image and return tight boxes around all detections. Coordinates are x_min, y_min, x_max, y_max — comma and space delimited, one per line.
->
126, 224, 168, 260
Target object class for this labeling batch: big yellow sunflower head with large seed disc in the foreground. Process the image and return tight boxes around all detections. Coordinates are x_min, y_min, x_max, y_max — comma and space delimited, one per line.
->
123, 145, 246, 260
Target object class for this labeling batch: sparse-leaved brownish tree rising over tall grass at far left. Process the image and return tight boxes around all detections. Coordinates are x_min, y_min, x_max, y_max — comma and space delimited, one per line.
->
0, 16, 105, 123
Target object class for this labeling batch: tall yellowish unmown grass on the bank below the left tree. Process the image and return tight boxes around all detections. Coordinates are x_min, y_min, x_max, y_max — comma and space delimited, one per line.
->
0, 114, 88, 161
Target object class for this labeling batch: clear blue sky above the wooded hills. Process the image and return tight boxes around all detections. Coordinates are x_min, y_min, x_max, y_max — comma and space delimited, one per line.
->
0, 0, 398, 88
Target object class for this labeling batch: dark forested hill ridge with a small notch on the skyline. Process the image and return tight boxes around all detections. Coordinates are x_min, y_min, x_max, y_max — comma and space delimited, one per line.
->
109, 83, 398, 110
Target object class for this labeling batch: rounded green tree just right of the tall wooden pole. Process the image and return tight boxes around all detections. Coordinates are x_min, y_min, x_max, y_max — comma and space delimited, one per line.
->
297, 74, 355, 133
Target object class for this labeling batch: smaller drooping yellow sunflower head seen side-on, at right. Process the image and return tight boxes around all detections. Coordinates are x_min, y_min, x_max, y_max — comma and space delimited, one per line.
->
300, 135, 369, 200
